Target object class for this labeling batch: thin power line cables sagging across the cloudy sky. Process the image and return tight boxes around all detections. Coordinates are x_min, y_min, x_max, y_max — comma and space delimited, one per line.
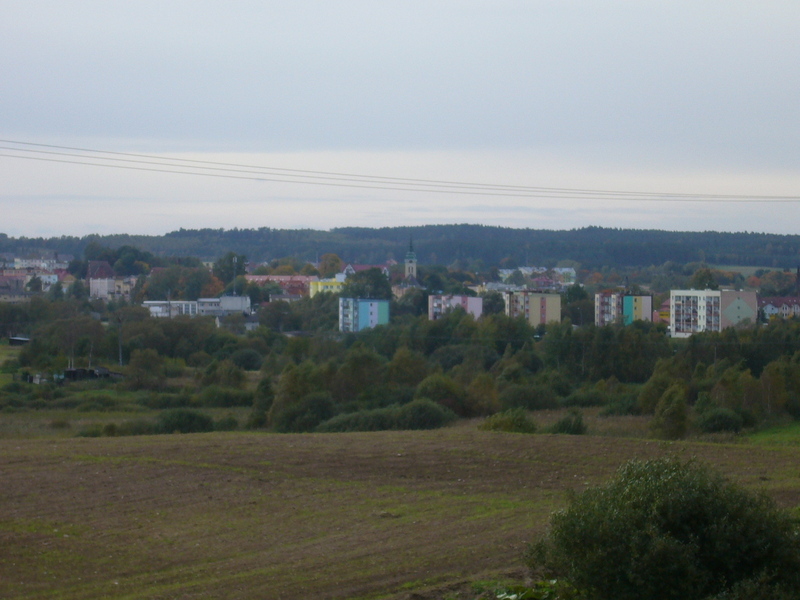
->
0, 139, 800, 203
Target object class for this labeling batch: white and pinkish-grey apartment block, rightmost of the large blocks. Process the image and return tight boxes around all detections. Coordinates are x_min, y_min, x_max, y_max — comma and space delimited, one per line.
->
669, 290, 758, 338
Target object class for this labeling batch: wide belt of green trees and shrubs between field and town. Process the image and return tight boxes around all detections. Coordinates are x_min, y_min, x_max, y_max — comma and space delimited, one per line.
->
0, 286, 800, 438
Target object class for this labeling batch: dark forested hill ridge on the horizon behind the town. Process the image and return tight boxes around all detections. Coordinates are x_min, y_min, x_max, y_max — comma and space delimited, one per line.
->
0, 225, 800, 268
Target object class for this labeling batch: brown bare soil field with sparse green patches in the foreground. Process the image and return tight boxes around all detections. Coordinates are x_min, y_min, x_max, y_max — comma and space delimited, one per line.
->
0, 423, 800, 600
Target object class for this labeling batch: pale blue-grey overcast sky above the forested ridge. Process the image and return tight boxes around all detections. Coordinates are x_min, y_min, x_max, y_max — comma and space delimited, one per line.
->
0, 0, 800, 237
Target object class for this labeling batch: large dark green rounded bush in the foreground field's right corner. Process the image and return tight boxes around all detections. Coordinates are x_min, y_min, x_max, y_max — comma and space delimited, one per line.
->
528, 458, 800, 600
